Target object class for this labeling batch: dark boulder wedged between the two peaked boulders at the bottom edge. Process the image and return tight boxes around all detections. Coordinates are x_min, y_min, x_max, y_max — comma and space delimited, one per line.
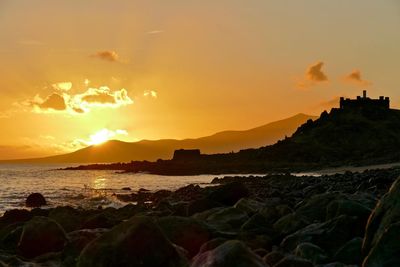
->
157, 216, 212, 258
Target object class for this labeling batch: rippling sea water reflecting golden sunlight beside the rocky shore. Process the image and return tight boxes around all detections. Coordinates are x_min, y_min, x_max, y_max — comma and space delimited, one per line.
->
0, 164, 231, 214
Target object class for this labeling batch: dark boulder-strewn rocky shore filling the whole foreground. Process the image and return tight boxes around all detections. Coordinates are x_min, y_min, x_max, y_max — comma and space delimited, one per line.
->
0, 169, 400, 267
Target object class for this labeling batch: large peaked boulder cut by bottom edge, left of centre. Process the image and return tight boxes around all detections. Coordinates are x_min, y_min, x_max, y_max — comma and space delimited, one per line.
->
77, 216, 188, 267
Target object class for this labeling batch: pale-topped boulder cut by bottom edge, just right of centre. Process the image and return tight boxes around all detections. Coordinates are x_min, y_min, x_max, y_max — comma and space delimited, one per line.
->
191, 240, 267, 267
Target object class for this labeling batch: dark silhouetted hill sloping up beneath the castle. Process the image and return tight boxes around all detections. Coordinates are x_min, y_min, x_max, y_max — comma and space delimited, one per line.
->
238, 108, 400, 166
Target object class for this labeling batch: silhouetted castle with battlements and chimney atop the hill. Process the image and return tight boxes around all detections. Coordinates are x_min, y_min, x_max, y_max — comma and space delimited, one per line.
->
340, 90, 390, 109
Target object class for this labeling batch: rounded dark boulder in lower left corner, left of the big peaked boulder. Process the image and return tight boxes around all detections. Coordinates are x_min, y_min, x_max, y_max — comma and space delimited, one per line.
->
18, 216, 67, 258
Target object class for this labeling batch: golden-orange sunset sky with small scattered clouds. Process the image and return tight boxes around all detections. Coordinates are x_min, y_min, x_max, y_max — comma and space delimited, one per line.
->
0, 0, 400, 159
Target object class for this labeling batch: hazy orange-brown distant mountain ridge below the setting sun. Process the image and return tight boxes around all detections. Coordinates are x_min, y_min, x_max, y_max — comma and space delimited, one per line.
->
0, 114, 317, 163
